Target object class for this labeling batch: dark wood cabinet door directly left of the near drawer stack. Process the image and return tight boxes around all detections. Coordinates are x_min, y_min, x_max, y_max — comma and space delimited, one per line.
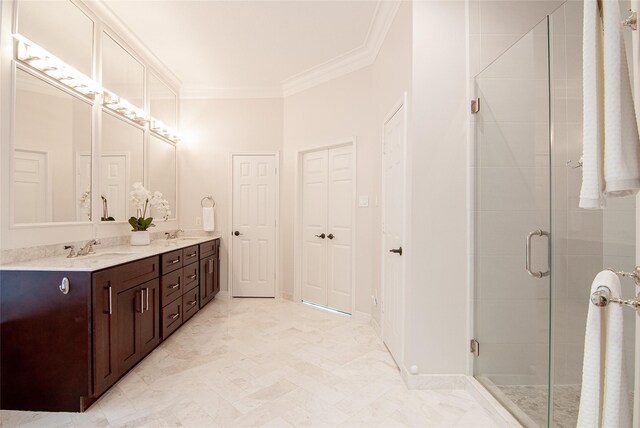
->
138, 278, 160, 358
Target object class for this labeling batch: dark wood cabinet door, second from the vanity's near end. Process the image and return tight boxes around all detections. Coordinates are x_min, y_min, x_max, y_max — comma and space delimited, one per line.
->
116, 286, 143, 375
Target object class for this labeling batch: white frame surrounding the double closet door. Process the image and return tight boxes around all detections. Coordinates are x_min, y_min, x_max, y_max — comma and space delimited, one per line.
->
293, 136, 358, 316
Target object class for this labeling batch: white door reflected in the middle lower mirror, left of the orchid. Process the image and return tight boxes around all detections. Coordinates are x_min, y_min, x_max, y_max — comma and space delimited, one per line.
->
100, 154, 127, 221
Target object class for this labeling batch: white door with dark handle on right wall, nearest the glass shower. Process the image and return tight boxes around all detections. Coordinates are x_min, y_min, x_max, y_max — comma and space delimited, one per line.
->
382, 105, 405, 362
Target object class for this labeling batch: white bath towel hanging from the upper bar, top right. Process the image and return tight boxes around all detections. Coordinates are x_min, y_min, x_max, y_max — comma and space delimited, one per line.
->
580, 0, 640, 209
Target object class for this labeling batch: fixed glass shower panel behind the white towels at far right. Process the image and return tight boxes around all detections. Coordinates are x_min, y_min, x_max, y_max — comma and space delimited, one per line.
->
550, 2, 636, 427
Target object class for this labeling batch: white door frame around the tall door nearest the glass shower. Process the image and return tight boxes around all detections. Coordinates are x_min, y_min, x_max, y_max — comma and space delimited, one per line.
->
378, 92, 411, 372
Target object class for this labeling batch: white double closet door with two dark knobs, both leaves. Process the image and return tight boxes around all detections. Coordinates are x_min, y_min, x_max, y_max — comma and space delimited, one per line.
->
302, 145, 354, 314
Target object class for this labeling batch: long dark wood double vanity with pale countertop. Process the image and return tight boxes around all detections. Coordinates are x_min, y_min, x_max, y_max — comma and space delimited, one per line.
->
0, 236, 220, 412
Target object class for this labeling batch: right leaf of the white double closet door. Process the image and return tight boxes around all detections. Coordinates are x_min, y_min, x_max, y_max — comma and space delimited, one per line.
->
326, 146, 354, 313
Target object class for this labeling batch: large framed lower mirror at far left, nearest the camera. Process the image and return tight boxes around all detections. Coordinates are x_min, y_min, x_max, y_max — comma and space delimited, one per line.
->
11, 68, 91, 224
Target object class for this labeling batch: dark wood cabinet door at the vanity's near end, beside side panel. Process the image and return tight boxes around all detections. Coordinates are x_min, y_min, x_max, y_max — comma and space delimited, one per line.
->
93, 272, 119, 396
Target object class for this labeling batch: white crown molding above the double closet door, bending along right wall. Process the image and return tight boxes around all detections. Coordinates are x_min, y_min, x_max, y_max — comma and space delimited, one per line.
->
282, 0, 402, 97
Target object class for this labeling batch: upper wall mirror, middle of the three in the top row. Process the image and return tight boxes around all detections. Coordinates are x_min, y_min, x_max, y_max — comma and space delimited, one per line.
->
102, 33, 144, 109
